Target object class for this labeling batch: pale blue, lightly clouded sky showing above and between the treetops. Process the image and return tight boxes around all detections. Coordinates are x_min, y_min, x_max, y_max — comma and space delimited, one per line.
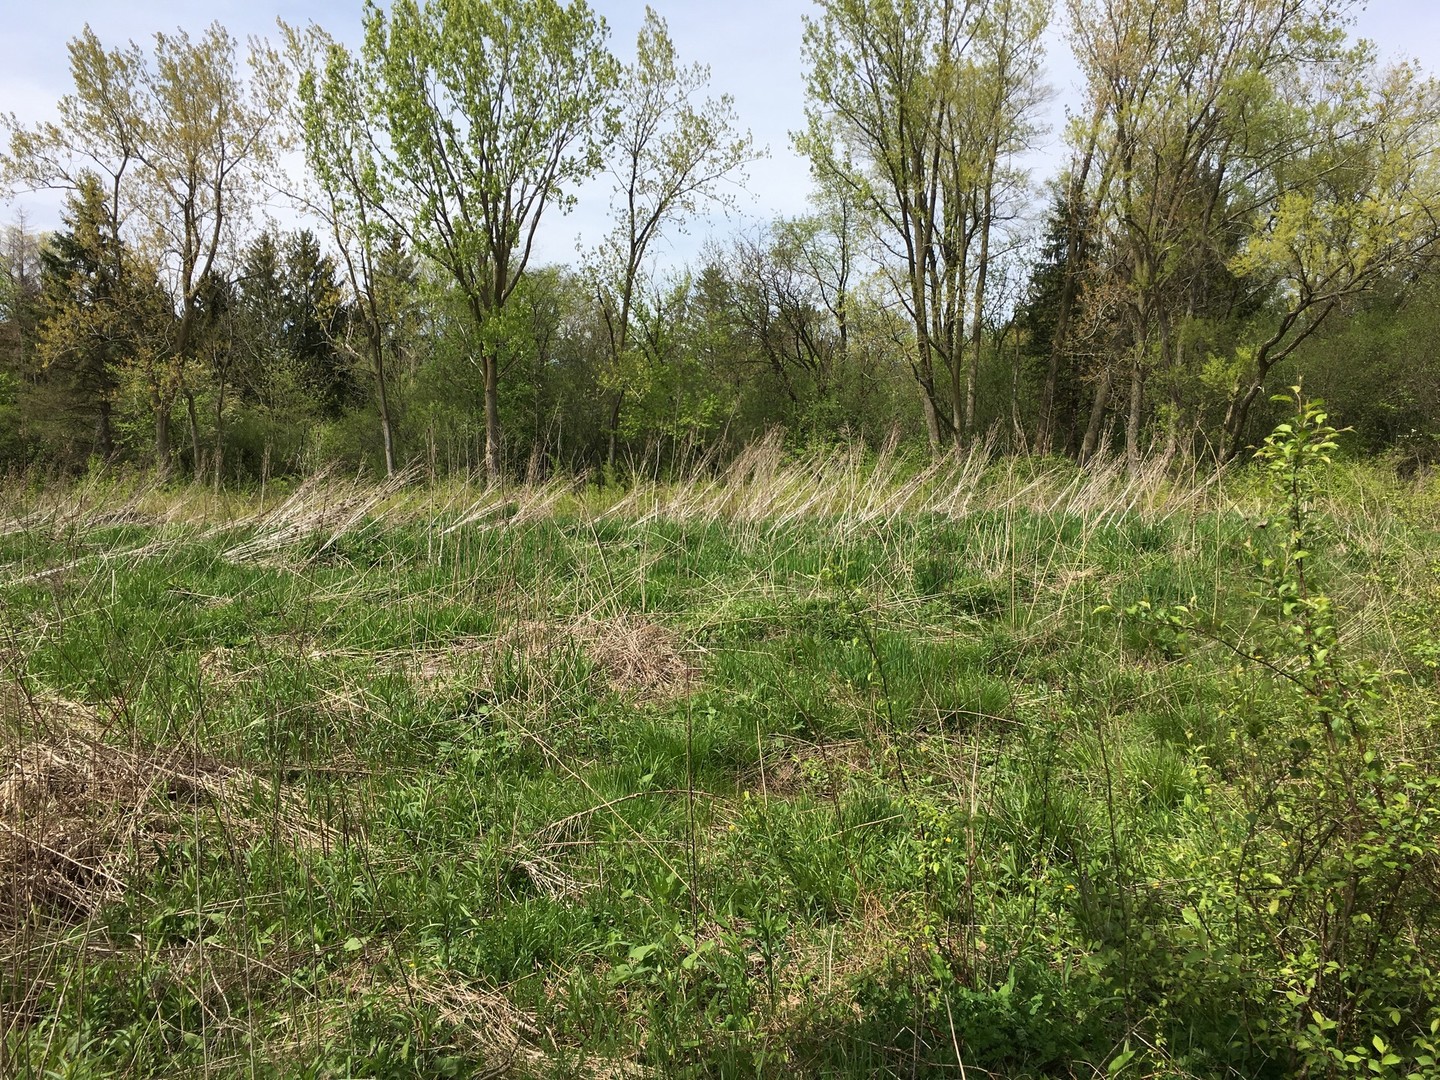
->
0, 0, 1440, 262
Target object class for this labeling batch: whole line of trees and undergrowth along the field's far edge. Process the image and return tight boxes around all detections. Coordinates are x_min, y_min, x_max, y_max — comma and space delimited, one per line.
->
0, 0, 1440, 482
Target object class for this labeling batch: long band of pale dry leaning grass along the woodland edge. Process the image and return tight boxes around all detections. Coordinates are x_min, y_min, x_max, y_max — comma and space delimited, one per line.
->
0, 433, 1224, 562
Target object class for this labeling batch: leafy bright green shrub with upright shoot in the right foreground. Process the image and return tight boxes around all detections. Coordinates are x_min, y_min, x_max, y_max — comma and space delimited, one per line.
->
1128, 400, 1440, 1076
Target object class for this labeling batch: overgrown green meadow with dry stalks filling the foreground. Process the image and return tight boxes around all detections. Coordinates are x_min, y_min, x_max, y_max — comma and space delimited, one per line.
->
0, 434, 1440, 1077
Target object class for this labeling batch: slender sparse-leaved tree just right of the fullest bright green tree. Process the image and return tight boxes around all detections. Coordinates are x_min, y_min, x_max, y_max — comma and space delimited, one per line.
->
595, 7, 757, 464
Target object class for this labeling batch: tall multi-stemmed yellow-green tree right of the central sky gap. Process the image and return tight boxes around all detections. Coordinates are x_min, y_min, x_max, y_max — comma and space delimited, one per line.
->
796, 0, 1050, 449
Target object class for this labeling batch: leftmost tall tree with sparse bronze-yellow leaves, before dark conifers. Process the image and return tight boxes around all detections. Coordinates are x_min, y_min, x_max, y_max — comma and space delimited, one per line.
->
0, 23, 284, 471
